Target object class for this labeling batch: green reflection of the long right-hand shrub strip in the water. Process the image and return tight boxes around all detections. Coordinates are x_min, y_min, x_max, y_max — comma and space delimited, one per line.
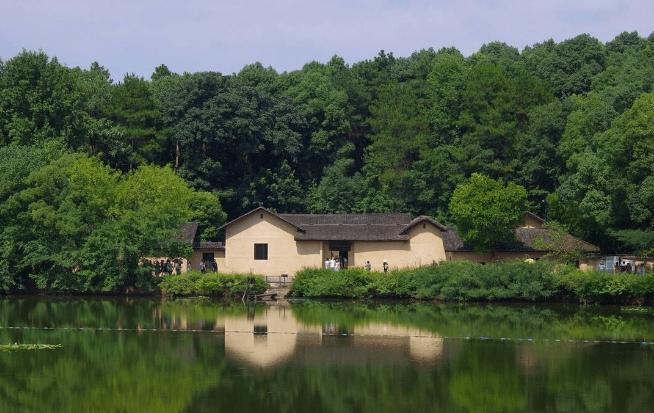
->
291, 301, 654, 342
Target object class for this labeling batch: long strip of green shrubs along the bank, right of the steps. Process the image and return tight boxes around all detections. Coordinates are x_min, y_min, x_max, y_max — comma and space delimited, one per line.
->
290, 260, 654, 304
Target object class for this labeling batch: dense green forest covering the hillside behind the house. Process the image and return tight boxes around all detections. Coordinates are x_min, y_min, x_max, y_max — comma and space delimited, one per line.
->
0, 32, 654, 290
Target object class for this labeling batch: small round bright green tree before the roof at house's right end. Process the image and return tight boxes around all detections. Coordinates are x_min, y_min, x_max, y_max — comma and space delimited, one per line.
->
450, 174, 527, 252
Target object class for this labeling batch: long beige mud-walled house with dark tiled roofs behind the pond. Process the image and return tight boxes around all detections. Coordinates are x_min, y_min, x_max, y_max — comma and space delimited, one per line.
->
182, 207, 599, 276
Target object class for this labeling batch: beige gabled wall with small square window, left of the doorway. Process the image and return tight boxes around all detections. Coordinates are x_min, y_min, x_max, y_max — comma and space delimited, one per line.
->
223, 211, 323, 276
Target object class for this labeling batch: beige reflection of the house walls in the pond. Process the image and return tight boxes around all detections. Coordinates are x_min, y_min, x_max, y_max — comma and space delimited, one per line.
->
224, 305, 443, 369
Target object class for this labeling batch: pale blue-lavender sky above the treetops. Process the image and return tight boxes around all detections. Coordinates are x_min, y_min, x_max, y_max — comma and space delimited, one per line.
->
0, 0, 654, 81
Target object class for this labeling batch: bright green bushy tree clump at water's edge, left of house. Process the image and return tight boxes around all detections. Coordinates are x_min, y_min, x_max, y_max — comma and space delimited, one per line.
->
2, 154, 192, 291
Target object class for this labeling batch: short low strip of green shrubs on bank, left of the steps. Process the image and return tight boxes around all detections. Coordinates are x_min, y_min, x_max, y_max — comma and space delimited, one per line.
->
159, 271, 269, 296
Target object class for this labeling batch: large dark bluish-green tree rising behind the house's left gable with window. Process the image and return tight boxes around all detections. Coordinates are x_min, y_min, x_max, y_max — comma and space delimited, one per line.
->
163, 73, 303, 216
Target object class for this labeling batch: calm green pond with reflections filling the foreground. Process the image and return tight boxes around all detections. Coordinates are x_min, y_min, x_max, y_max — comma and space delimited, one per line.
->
0, 298, 654, 412
